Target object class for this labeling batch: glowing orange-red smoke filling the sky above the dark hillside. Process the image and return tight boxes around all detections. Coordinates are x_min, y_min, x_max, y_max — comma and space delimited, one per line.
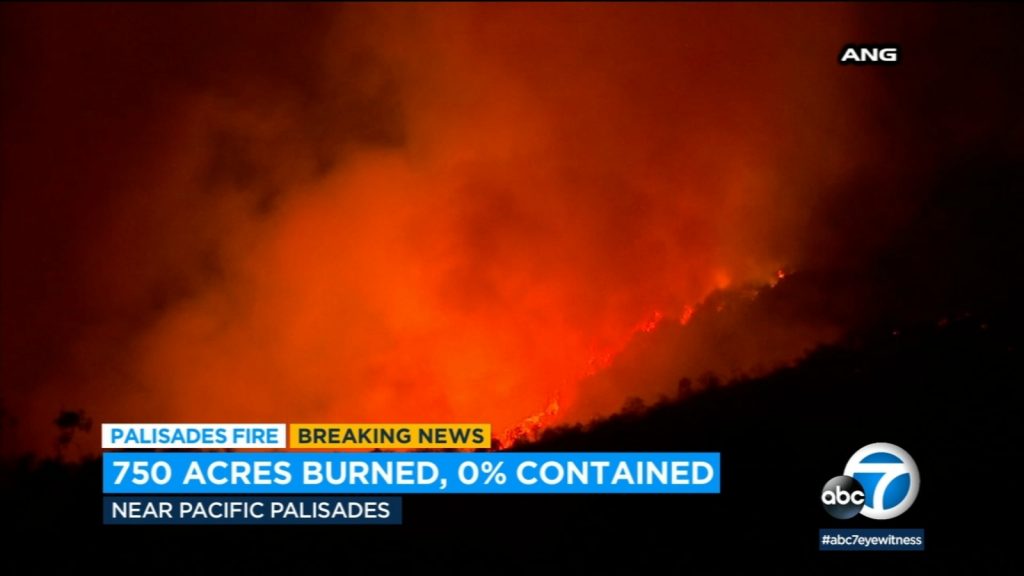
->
2, 5, 1019, 449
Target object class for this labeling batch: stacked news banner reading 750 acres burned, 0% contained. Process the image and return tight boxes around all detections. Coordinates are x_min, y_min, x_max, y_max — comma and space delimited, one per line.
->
102, 423, 720, 524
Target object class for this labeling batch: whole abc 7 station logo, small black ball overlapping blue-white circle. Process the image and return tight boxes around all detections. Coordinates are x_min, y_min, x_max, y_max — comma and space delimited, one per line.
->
821, 442, 921, 520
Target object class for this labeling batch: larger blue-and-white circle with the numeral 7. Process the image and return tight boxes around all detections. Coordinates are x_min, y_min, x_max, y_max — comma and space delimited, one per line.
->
847, 442, 921, 520
